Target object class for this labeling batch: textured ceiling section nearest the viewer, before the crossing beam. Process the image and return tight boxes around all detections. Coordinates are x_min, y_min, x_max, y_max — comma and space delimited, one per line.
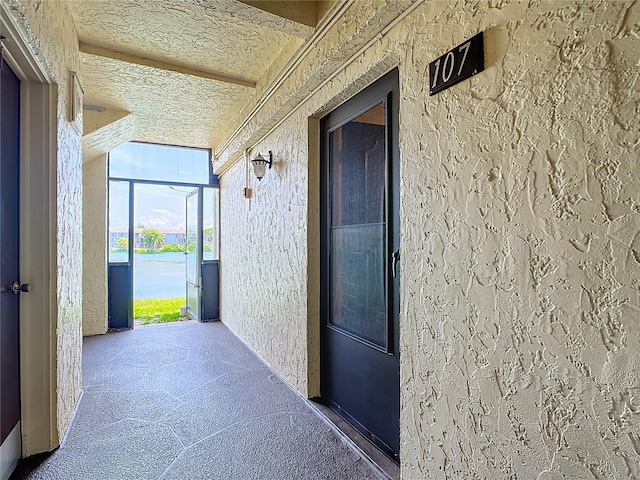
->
72, 0, 287, 81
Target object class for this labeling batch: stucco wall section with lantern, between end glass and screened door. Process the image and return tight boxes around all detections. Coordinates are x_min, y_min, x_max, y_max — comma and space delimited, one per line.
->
220, 110, 308, 393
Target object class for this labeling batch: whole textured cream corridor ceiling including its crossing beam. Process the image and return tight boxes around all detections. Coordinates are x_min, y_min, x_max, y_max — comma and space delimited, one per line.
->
69, 0, 326, 148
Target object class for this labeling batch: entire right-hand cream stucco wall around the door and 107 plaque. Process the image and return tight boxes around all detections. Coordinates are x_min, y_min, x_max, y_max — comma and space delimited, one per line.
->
221, 2, 640, 479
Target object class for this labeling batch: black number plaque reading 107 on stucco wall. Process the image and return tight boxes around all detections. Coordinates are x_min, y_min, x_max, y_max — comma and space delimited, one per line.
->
429, 32, 484, 95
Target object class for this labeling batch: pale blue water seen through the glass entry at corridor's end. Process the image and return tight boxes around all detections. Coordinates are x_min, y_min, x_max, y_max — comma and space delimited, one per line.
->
110, 252, 186, 300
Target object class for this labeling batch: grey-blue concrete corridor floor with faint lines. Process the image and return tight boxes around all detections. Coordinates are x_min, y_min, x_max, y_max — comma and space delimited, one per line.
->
12, 322, 387, 480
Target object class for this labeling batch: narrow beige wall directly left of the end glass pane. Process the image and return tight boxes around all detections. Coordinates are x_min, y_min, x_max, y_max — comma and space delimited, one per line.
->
82, 154, 109, 336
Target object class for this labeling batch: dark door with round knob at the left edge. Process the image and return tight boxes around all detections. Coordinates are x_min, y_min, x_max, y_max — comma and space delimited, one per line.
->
0, 53, 27, 480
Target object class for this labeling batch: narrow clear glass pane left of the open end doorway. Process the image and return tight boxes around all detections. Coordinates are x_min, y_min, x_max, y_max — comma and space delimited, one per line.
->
109, 181, 129, 263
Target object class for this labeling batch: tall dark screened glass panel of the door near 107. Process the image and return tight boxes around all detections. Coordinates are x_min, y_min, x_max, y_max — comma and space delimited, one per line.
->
329, 102, 389, 348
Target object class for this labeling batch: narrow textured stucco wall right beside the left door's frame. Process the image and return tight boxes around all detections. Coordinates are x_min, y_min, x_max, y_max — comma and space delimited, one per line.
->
8, 0, 82, 438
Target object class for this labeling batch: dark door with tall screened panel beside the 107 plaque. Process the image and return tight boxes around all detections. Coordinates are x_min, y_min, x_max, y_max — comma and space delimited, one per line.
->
321, 70, 400, 461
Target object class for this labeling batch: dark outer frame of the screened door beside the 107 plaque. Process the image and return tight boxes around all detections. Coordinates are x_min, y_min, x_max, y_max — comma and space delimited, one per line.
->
320, 68, 400, 464
